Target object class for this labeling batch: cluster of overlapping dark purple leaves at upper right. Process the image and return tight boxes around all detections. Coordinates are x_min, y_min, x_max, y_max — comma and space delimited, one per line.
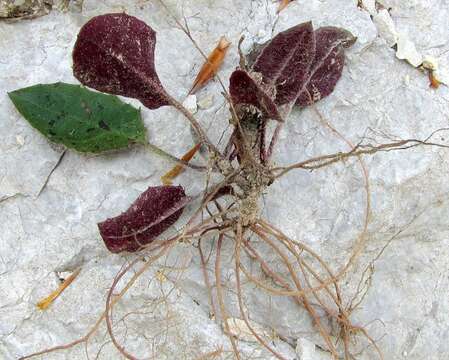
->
229, 22, 356, 121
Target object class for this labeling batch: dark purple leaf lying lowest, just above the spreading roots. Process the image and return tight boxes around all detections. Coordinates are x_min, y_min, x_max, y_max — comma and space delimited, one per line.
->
98, 186, 190, 253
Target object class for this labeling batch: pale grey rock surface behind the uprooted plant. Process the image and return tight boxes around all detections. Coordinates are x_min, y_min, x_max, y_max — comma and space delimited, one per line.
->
0, 0, 449, 360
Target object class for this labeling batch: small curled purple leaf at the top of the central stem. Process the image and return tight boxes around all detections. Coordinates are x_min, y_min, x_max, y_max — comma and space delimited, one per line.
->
229, 70, 283, 121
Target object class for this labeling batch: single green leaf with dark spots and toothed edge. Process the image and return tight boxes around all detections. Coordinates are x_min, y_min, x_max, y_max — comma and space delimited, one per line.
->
8, 83, 146, 153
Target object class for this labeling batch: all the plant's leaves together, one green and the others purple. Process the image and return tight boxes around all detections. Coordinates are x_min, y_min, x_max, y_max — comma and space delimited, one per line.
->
9, 13, 355, 252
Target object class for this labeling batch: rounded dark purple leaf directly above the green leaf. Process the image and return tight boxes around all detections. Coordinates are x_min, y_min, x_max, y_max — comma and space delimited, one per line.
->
73, 13, 169, 109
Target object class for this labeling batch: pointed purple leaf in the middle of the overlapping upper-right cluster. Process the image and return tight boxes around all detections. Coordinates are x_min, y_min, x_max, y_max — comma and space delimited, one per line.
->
253, 22, 315, 105
